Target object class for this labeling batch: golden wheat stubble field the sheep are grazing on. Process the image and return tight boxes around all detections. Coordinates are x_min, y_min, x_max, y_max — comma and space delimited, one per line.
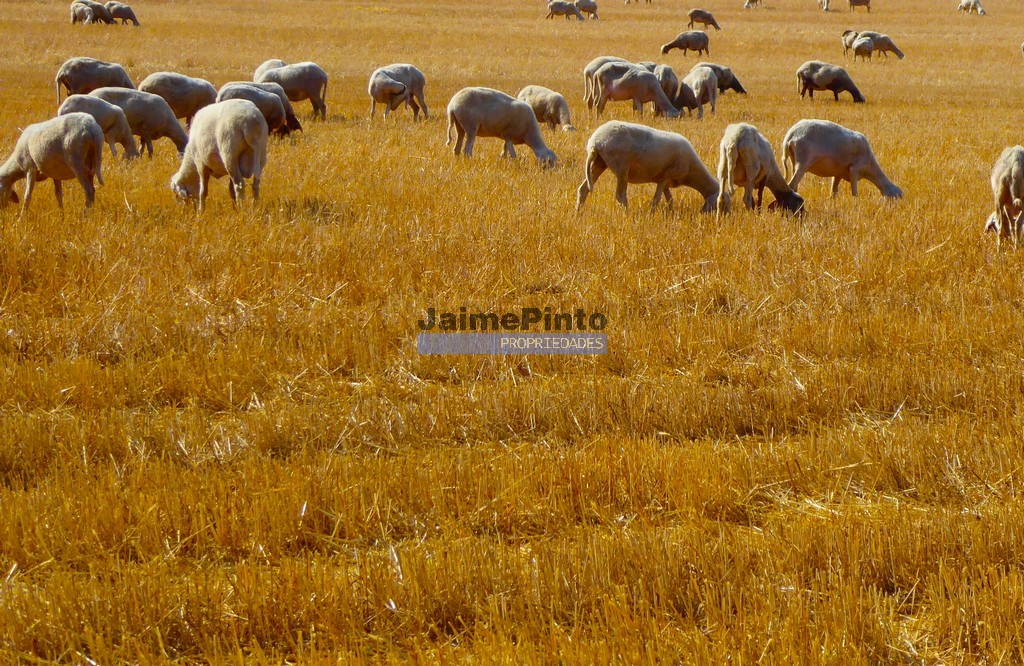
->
0, 0, 1024, 664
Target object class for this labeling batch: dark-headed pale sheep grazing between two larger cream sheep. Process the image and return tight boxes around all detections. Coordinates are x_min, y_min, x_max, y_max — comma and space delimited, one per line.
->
718, 123, 804, 213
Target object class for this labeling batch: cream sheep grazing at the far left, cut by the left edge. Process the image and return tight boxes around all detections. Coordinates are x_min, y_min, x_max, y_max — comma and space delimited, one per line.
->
0, 113, 103, 213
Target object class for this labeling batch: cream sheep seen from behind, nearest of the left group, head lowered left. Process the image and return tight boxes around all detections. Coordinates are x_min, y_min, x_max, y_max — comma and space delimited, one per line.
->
171, 99, 267, 212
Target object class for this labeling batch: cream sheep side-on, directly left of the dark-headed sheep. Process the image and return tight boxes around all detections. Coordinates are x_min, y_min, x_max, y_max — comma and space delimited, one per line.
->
577, 120, 721, 213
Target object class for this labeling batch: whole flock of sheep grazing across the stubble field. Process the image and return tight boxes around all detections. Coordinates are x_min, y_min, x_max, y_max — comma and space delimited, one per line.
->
0, 0, 1024, 243
